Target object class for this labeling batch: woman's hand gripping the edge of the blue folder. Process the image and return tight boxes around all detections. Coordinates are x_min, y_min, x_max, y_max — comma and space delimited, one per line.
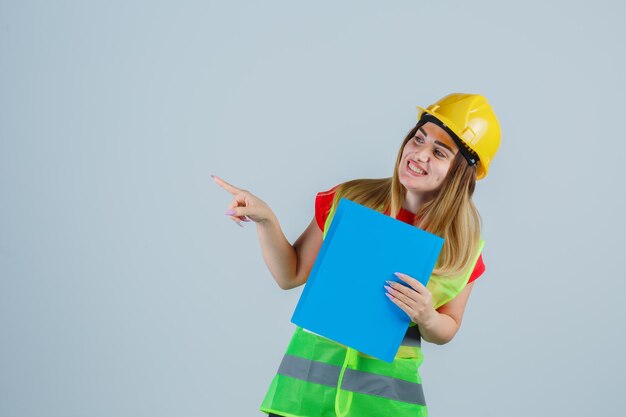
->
385, 272, 437, 326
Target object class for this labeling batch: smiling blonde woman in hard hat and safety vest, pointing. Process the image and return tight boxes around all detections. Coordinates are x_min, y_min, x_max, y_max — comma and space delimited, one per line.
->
214, 93, 500, 417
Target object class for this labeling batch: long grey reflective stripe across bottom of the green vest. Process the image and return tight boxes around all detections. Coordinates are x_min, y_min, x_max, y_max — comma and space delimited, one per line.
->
278, 354, 426, 405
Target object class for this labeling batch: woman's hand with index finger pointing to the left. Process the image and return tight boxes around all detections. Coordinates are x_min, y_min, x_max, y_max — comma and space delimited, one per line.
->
211, 175, 274, 226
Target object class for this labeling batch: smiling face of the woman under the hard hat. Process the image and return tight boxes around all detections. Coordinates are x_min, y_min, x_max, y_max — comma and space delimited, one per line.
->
398, 122, 459, 198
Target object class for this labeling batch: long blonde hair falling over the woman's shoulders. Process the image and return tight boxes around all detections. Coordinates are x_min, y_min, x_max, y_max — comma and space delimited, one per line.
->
333, 126, 480, 276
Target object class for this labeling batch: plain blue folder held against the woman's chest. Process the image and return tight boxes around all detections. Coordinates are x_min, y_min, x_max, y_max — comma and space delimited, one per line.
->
291, 198, 443, 362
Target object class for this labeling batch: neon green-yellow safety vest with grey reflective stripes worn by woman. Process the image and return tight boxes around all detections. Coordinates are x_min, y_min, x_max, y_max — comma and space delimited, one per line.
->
260, 197, 484, 417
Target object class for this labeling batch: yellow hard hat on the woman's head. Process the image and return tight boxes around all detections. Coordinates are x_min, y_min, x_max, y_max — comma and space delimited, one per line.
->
417, 93, 500, 180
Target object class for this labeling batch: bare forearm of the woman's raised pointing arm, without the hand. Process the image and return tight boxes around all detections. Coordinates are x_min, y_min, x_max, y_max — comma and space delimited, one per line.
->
257, 216, 298, 290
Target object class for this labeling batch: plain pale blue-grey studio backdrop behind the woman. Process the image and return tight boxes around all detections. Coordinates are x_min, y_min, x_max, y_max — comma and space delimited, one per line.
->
0, 0, 626, 417
